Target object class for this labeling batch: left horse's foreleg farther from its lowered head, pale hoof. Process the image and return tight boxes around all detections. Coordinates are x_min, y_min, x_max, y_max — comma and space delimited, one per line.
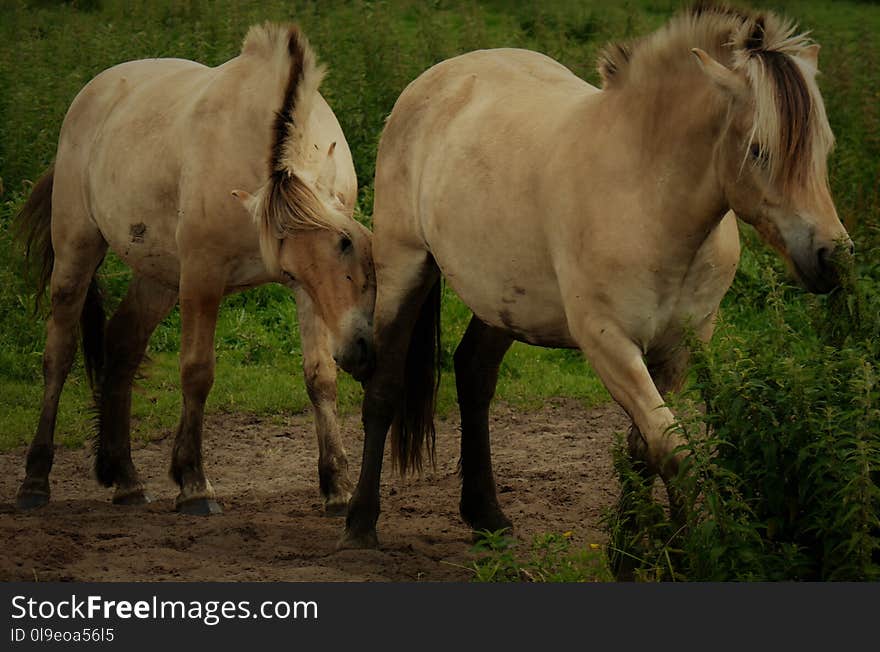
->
171, 265, 225, 516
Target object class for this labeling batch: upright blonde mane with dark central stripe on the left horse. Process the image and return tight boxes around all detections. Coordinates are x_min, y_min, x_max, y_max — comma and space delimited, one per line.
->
241, 23, 347, 273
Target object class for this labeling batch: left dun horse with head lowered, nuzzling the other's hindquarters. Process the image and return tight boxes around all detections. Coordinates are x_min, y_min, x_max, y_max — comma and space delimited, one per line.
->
16, 23, 375, 515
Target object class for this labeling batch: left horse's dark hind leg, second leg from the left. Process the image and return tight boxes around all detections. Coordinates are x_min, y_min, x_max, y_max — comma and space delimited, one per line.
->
95, 275, 177, 505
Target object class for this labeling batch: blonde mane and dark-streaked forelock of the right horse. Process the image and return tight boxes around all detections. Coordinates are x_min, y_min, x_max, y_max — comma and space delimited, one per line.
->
598, 2, 834, 195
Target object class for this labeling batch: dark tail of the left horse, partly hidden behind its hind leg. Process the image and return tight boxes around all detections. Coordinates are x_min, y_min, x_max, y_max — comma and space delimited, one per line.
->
14, 163, 105, 391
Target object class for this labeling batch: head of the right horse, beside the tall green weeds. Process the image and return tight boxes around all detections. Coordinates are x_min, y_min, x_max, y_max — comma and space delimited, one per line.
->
693, 15, 853, 293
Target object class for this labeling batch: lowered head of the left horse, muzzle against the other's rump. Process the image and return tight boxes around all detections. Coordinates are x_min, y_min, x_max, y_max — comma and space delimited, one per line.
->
232, 145, 376, 380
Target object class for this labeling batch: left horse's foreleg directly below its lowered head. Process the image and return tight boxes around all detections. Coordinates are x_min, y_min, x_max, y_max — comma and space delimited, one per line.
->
296, 290, 352, 515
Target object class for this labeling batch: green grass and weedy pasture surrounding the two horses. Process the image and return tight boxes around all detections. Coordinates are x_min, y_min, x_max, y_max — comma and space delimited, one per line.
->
0, 0, 880, 579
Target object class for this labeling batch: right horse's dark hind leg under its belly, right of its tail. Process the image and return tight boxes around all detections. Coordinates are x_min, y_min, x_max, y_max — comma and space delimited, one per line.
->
455, 317, 513, 532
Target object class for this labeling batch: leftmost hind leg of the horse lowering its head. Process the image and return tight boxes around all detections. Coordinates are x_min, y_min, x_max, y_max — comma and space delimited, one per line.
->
16, 228, 107, 509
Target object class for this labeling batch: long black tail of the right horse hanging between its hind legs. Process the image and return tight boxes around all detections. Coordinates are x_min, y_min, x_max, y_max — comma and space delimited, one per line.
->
391, 278, 440, 474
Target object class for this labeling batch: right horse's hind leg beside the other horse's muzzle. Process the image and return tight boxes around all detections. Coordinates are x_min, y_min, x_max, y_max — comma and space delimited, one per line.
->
338, 251, 438, 548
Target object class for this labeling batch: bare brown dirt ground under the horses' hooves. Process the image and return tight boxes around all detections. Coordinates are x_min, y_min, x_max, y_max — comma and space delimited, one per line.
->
0, 401, 628, 581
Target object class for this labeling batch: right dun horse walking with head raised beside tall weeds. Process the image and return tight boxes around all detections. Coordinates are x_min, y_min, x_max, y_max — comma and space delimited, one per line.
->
339, 5, 852, 548
